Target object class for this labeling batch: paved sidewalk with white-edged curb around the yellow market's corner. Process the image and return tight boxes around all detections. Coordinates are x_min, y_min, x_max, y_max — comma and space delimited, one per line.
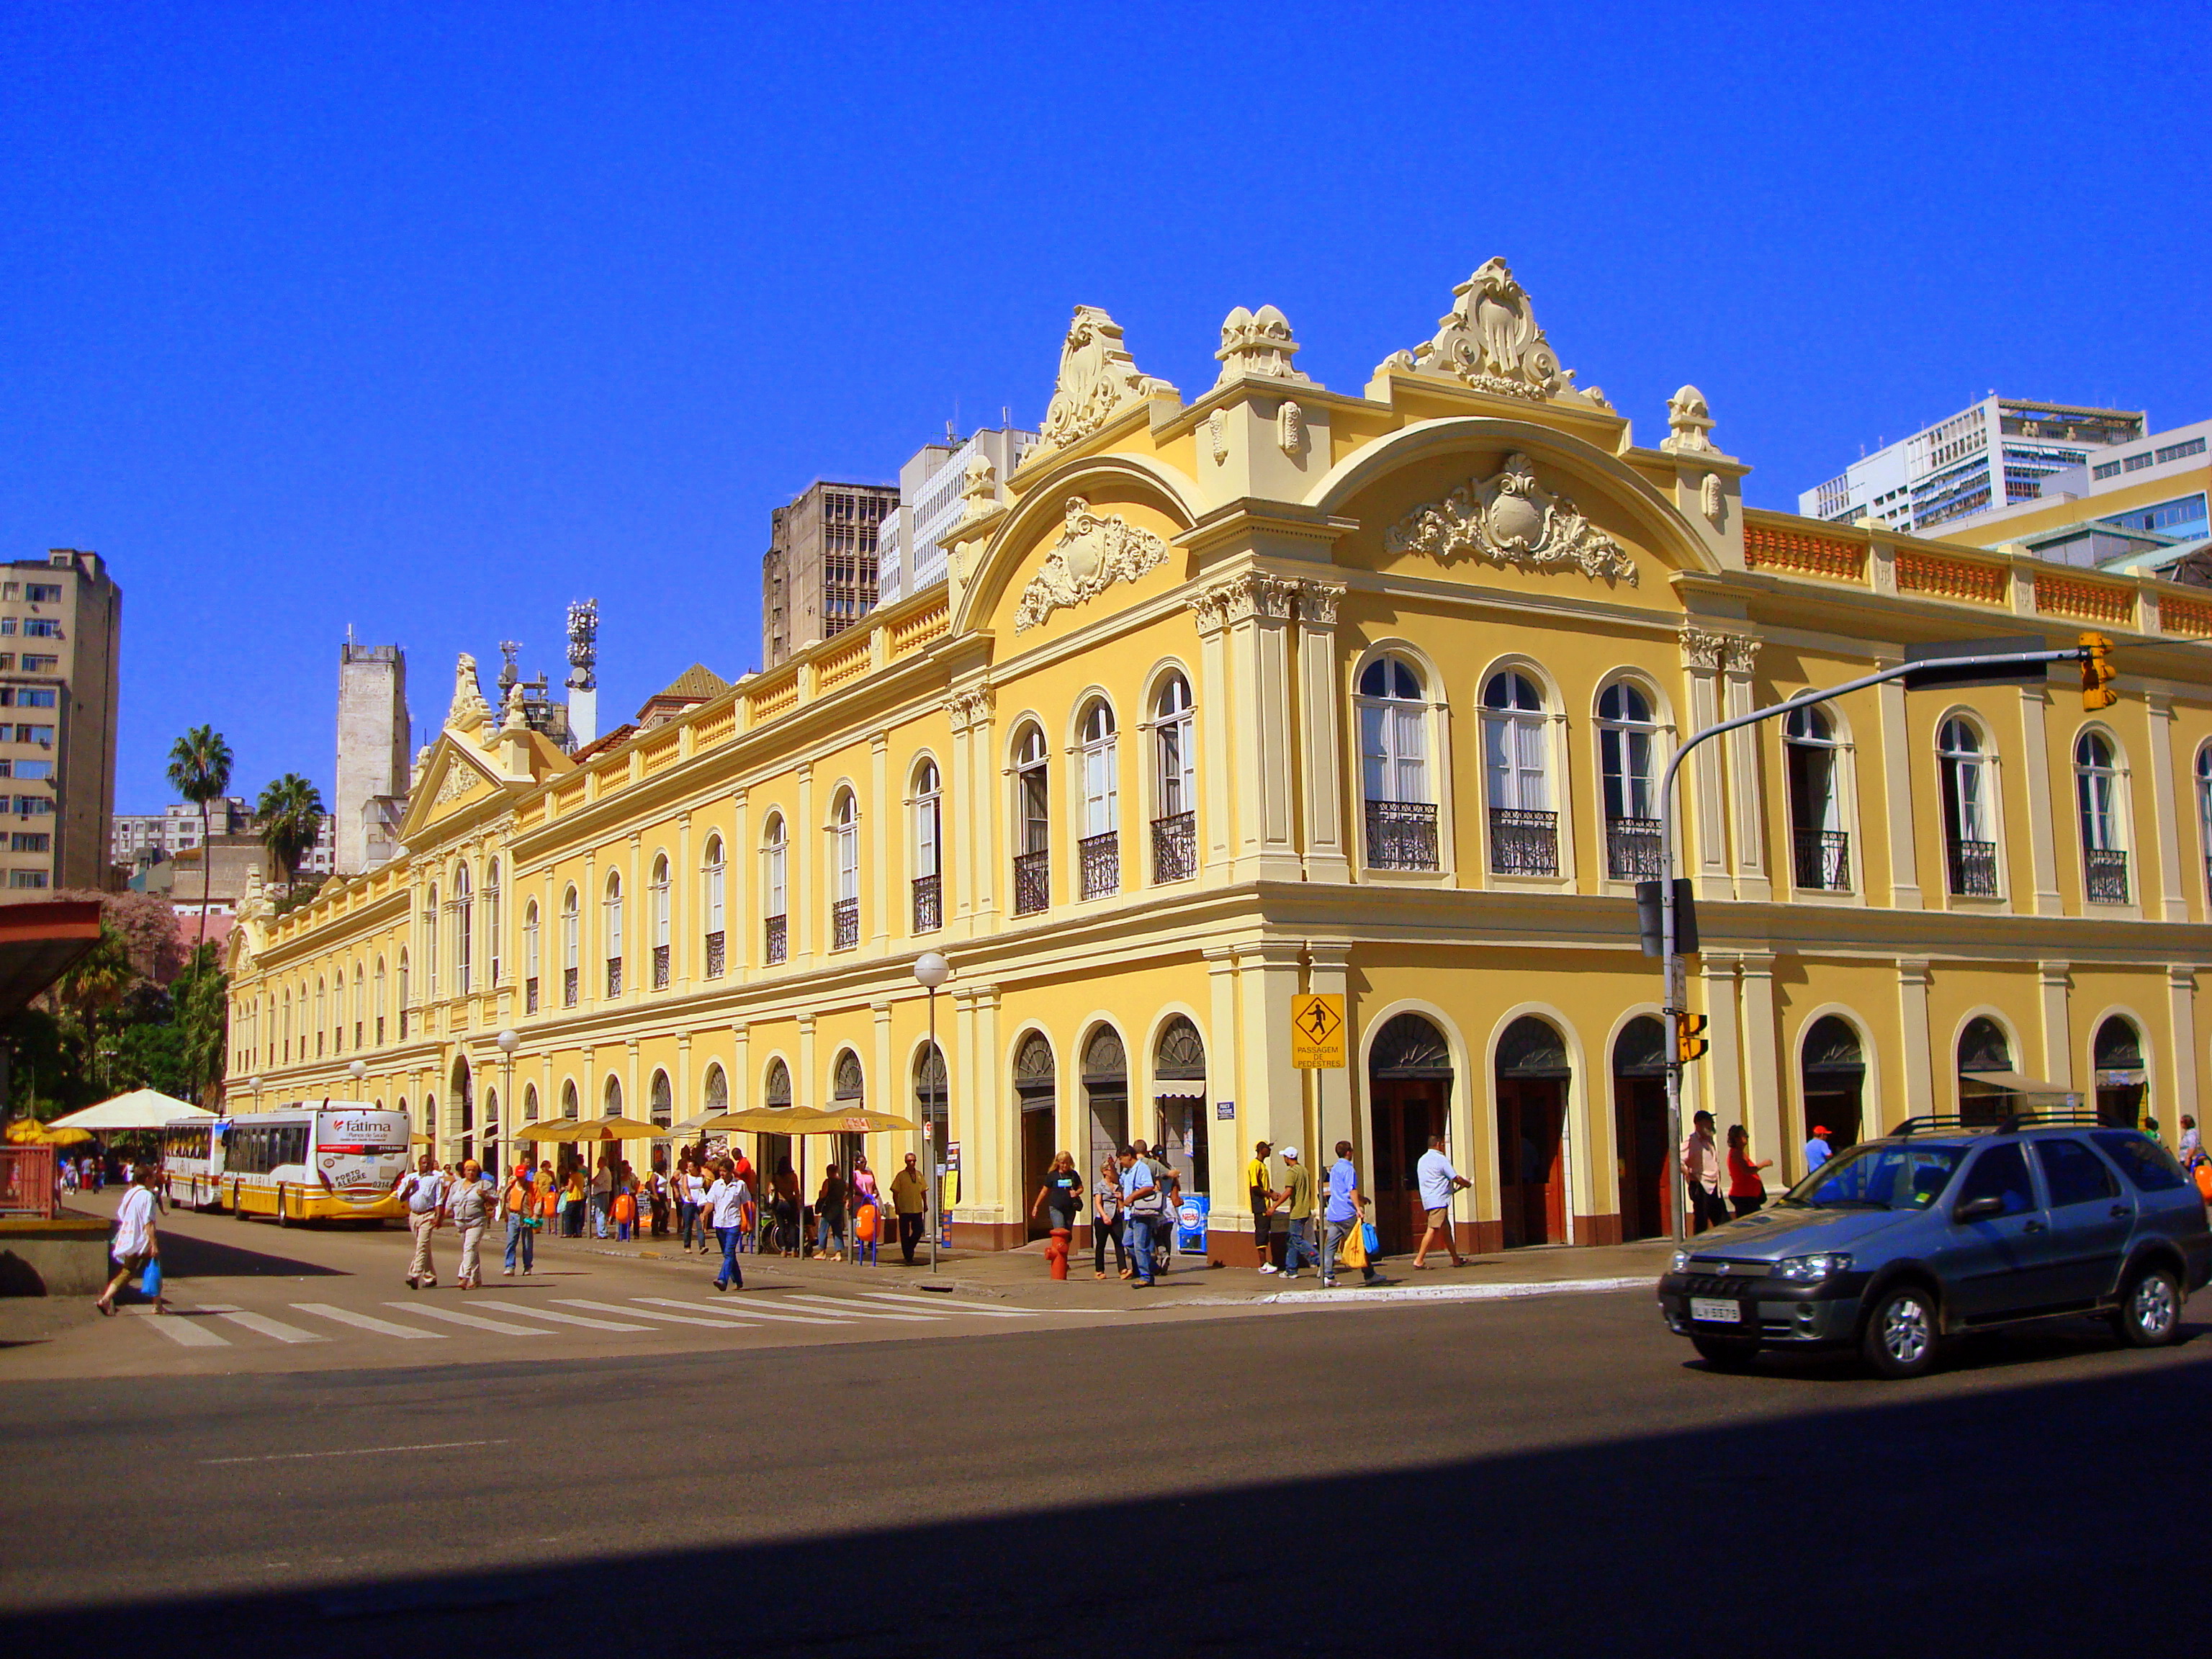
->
535, 1236, 1675, 1312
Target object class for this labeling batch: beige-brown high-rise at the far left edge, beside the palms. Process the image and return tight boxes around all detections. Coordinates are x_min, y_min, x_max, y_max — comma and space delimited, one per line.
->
0, 547, 124, 898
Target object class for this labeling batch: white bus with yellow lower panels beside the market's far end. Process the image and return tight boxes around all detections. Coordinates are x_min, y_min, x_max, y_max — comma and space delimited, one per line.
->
161, 1102, 407, 1226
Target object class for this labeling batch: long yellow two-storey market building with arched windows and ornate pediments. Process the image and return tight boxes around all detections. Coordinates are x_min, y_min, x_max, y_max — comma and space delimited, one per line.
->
228, 261, 2212, 1261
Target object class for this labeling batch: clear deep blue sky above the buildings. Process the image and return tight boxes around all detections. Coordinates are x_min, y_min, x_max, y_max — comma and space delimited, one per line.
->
0, 0, 2212, 809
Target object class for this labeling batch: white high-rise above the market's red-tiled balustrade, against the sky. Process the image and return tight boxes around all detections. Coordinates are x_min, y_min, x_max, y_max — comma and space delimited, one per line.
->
1799, 392, 2146, 535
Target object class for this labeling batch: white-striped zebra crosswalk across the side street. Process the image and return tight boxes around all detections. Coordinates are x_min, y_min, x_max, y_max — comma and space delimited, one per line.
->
135, 1290, 1048, 1349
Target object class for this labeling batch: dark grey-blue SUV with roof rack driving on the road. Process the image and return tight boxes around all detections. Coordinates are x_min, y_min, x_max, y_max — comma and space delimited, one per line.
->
1659, 1117, 2212, 1376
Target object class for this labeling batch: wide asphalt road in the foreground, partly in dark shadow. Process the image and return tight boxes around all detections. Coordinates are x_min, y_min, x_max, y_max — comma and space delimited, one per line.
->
0, 1230, 2212, 1659
